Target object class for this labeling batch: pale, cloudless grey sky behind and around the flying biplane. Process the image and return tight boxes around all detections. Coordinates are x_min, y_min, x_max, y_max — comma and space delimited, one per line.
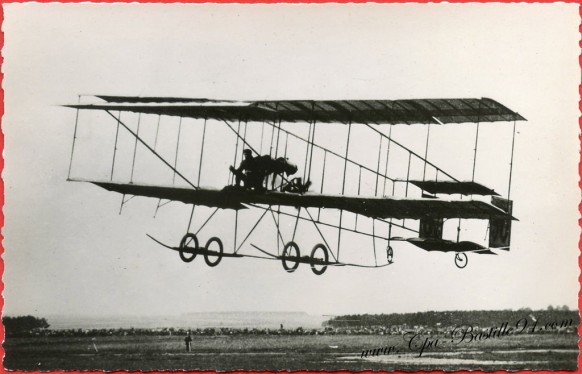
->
2, 3, 580, 316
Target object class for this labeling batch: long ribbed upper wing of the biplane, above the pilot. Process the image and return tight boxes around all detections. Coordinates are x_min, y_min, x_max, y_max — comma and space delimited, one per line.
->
67, 96, 525, 125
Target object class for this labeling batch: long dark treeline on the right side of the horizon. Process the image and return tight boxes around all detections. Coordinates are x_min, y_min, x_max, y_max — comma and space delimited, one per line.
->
327, 308, 580, 328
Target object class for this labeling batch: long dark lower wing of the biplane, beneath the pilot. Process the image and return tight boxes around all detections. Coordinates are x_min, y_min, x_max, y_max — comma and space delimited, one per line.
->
92, 182, 514, 219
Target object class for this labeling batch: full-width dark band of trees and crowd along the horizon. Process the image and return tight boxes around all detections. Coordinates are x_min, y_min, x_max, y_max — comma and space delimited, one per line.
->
2, 307, 580, 337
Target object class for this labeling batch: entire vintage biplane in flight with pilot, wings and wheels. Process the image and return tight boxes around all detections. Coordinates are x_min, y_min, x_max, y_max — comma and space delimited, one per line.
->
66, 96, 525, 275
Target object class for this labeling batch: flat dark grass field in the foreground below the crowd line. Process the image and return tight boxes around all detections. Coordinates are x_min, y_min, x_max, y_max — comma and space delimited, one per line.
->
4, 334, 578, 371
